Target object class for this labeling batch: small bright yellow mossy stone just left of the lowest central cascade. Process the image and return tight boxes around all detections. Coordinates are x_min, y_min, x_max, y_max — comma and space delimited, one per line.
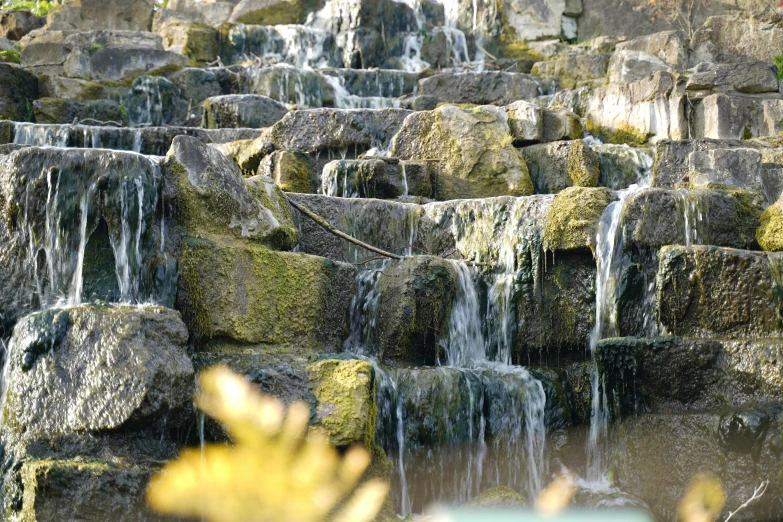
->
307, 359, 376, 448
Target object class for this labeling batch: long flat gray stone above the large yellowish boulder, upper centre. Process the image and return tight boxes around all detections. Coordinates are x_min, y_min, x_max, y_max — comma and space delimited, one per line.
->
419, 71, 538, 105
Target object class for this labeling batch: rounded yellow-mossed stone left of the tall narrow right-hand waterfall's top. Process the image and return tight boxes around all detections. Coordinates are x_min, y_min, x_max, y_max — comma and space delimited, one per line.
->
544, 187, 613, 251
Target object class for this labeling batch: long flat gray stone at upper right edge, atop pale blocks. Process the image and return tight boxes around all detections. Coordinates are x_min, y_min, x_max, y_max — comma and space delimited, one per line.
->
685, 62, 779, 94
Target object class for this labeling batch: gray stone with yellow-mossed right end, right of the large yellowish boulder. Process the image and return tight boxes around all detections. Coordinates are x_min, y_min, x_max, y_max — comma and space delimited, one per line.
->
521, 140, 599, 194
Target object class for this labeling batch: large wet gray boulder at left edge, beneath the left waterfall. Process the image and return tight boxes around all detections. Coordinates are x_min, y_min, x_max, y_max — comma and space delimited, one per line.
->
3, 305, 194, 436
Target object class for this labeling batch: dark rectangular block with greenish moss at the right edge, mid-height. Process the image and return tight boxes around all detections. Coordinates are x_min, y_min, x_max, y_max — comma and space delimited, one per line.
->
656, 246, 782, 339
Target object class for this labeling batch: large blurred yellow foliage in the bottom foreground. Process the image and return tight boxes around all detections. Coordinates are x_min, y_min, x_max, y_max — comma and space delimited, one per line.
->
147, 366, 389, 522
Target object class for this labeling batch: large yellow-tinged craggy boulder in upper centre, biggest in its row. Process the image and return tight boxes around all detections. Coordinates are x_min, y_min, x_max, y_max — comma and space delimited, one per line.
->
392, 105, 533, 197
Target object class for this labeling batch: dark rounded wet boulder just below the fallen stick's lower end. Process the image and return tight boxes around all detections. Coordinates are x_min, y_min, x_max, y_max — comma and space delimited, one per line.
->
377, 256, 457, 365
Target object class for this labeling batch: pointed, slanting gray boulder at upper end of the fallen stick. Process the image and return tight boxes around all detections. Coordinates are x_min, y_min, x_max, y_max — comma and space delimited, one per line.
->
163, 136, 298, 249
